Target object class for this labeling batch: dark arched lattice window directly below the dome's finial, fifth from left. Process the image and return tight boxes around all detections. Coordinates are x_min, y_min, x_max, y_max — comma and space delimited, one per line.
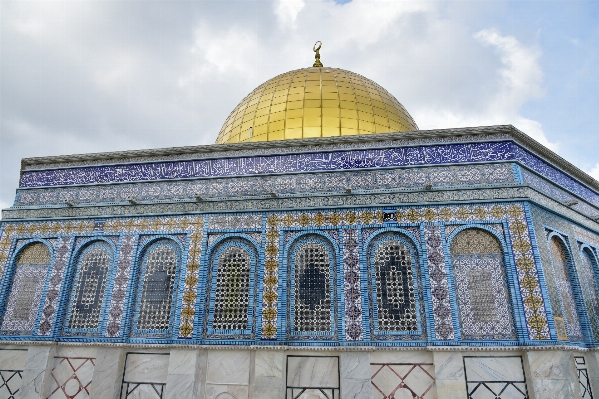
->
292, 241, 332, 333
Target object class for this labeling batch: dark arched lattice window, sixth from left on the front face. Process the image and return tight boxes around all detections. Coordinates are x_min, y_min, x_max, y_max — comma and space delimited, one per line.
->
374, 240, 418, 332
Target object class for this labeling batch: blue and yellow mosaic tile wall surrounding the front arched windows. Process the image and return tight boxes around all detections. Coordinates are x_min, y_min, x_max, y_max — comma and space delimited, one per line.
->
0, 202, 599, 346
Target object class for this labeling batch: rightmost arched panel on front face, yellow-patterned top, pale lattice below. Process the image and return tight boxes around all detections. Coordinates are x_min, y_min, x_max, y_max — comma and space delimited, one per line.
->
451, 228, 516, 339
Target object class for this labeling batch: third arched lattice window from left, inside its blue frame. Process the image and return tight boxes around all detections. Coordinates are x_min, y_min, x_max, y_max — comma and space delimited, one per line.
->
135, 241, 179, 330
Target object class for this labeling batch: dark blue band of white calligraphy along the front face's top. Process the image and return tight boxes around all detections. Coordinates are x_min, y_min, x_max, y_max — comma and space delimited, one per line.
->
19, 142, 514, 188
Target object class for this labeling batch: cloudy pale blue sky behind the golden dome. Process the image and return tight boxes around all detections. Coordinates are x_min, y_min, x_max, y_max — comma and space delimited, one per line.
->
0, 0, 599, 208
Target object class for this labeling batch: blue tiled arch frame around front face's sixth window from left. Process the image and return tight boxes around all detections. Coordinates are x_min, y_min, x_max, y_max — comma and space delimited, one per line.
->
363, 228, 429, 340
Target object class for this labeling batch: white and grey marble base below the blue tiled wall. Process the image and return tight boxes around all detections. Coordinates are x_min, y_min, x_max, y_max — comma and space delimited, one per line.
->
0, 345, 599, 399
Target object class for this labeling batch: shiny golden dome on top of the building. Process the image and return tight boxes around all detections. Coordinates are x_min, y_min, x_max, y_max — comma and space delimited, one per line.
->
216, 67, 418, 144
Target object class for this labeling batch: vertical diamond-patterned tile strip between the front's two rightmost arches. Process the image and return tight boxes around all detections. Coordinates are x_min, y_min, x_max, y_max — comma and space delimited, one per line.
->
424, 226, 454, 340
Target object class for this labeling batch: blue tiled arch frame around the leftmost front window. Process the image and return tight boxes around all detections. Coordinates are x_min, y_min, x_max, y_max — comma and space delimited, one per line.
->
0, 238, 55, 337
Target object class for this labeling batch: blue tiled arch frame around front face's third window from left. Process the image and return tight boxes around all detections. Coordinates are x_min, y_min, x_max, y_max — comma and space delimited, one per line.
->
132, 236, 183, 341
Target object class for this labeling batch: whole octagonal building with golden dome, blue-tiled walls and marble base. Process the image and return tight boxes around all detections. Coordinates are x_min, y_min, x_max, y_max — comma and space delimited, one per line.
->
0, 67, 599, 399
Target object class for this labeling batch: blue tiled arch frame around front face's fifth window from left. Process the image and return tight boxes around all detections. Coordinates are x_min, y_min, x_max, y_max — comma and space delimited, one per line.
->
281, 230, 343, 341
